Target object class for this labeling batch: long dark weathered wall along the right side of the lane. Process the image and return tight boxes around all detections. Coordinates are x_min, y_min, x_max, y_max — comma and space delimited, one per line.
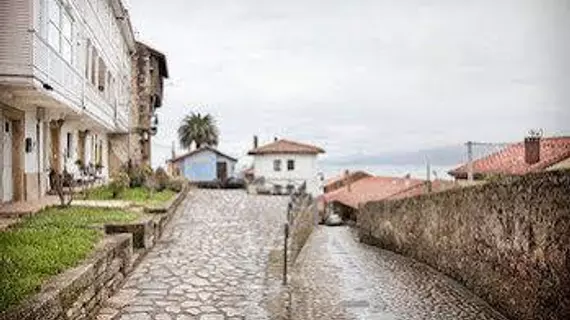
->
358, 171, 570, 320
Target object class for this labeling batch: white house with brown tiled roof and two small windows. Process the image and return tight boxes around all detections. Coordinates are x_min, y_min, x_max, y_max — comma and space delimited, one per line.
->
248, 139, 325, 195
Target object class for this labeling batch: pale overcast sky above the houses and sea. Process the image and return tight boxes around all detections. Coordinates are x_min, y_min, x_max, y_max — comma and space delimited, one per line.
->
127, 0, 570, 169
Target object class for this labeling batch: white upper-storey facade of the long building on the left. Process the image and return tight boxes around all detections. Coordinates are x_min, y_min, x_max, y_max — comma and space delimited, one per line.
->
0, 0, 134, 132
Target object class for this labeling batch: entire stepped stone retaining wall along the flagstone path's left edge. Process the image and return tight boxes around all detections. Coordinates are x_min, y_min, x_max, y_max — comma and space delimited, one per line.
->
0, 187, 189, 320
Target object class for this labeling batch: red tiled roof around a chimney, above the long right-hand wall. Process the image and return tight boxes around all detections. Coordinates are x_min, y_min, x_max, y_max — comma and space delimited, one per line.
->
449, 137, 570, 178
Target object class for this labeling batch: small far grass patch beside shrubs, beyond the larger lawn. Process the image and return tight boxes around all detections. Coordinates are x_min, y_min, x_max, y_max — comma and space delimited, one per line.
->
80, 186, 176, 205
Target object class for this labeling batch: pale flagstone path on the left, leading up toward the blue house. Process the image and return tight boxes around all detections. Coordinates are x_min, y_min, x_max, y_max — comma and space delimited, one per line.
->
98, 190, 288, 320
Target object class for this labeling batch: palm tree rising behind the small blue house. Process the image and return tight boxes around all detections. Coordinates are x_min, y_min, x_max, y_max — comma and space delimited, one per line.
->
178, 112, 219, 149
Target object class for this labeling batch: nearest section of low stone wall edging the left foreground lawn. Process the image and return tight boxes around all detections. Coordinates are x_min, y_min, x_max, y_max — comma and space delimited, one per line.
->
0, 234, 133, 320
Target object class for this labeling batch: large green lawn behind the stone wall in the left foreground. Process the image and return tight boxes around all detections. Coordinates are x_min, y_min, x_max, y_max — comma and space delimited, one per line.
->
0, 207, 138, 312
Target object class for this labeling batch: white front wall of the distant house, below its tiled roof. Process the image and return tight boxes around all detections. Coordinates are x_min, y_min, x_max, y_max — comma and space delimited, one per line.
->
253, 154, 320, 195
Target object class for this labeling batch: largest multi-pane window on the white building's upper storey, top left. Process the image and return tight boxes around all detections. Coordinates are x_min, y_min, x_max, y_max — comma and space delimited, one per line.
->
47, 0, 73, 63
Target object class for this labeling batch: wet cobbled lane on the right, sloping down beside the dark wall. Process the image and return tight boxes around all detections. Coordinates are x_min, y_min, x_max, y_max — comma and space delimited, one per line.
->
291, 227, 506, 320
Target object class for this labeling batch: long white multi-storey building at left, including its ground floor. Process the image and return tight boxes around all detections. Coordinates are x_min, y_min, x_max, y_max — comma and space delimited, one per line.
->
0, 0, 136, 202
